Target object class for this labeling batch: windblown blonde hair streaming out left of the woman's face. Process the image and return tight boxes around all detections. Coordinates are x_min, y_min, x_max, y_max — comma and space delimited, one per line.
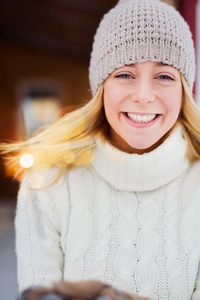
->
0, 85, 104, 173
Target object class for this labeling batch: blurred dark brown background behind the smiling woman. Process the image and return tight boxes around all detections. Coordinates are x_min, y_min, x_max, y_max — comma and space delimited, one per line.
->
0, 0, 200, 300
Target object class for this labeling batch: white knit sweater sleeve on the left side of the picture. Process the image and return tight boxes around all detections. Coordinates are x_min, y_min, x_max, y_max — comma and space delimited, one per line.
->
15, 173, 68, 291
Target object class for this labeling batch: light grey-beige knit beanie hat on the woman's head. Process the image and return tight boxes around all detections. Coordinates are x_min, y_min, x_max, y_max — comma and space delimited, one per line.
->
89, 0, 195, 96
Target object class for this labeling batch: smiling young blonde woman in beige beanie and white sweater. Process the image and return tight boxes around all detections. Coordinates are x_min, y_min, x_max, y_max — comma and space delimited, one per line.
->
1, 0, 200, 300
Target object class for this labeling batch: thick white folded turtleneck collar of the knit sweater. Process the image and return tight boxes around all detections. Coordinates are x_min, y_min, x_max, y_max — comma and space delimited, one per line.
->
93, 125, 189, 192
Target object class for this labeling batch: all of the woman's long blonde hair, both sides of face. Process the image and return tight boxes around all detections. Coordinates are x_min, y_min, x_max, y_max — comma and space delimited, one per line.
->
0, 76, 200, 177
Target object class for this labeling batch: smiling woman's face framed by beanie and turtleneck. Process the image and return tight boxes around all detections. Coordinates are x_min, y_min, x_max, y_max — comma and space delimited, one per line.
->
104, 61, 182, 154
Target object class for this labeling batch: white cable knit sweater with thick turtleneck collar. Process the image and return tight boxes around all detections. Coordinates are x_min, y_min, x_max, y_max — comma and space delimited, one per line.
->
16, 127, 200, 300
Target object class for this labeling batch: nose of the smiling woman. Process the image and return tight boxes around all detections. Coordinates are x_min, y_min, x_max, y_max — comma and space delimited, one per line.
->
132, 80, 156, 105
